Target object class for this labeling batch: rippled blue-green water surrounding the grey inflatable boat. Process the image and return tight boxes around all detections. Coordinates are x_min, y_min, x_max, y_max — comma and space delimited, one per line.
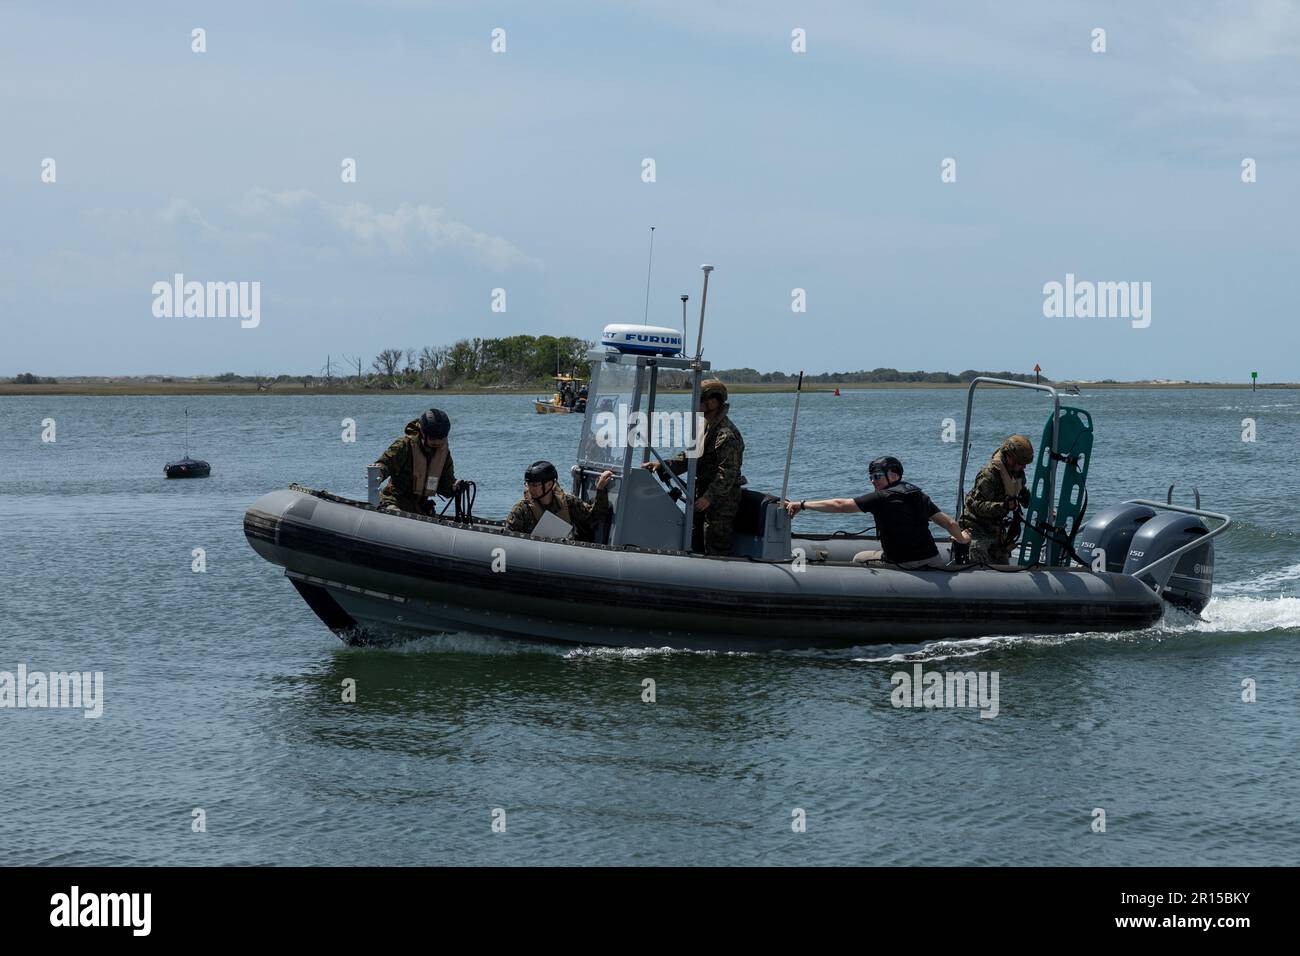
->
0, 389, 1300, 865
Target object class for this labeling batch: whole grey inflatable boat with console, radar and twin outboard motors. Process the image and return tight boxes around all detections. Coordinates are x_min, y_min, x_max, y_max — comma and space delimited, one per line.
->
244, 267, 1229, 650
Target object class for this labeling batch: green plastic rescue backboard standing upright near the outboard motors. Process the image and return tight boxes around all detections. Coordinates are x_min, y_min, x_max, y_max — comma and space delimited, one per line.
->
1021, 408, 1092, 566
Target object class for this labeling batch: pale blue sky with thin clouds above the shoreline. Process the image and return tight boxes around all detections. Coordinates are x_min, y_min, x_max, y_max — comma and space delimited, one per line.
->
0, 0, 1300, 381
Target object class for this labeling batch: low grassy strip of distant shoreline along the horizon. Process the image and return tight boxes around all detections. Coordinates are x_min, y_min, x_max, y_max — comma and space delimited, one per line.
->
0, 381, 1284, 398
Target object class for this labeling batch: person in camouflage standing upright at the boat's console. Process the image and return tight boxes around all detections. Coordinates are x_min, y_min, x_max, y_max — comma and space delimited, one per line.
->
641, 378, 745, 554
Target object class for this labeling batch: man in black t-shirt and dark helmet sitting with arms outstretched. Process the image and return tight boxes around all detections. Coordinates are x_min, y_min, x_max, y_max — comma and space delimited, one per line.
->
785, 455, 970, 571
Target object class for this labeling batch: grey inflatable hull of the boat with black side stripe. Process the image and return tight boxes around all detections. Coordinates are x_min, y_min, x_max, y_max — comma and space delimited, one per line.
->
244, 489, 1180, 650
